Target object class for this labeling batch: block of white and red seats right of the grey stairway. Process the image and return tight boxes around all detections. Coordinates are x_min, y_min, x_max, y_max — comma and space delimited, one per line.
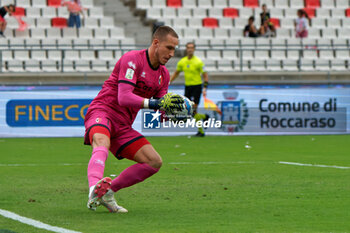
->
136, 0, 350, 71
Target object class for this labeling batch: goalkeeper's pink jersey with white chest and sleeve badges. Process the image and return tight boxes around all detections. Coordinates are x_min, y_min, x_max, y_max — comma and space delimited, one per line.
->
86, 50, 170, 125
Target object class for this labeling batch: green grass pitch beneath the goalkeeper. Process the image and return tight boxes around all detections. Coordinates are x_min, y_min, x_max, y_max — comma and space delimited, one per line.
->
0, 135, 350, 233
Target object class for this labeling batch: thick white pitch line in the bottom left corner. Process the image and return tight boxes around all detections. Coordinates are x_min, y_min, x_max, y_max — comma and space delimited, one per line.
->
0, 209, 81, 233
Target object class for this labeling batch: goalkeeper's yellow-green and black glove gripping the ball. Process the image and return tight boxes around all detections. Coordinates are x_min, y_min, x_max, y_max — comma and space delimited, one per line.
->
149, 93, 184, 112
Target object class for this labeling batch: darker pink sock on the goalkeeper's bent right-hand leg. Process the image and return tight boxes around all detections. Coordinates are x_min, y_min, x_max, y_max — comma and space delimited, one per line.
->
110, 163, 159, 192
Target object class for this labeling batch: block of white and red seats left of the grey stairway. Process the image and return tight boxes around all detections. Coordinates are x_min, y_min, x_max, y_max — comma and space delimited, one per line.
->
0, 0, 135, 73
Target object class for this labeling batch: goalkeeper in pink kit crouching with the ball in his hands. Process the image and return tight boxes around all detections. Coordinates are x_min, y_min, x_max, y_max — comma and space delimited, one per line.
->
84, 26, 183, 213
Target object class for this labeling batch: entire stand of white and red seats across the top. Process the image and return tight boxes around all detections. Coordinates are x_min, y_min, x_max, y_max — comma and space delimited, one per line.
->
0, 0, 350, 76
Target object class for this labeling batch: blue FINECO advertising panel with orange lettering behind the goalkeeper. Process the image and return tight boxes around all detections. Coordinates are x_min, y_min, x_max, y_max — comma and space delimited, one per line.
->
6, 99, 92, 127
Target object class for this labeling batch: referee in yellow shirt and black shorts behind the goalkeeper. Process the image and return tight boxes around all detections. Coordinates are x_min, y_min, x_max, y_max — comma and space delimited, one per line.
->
170, 42, 209, 137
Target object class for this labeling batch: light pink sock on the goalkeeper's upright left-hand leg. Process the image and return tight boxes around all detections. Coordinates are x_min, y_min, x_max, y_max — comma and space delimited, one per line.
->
88, 146, 108, 187
